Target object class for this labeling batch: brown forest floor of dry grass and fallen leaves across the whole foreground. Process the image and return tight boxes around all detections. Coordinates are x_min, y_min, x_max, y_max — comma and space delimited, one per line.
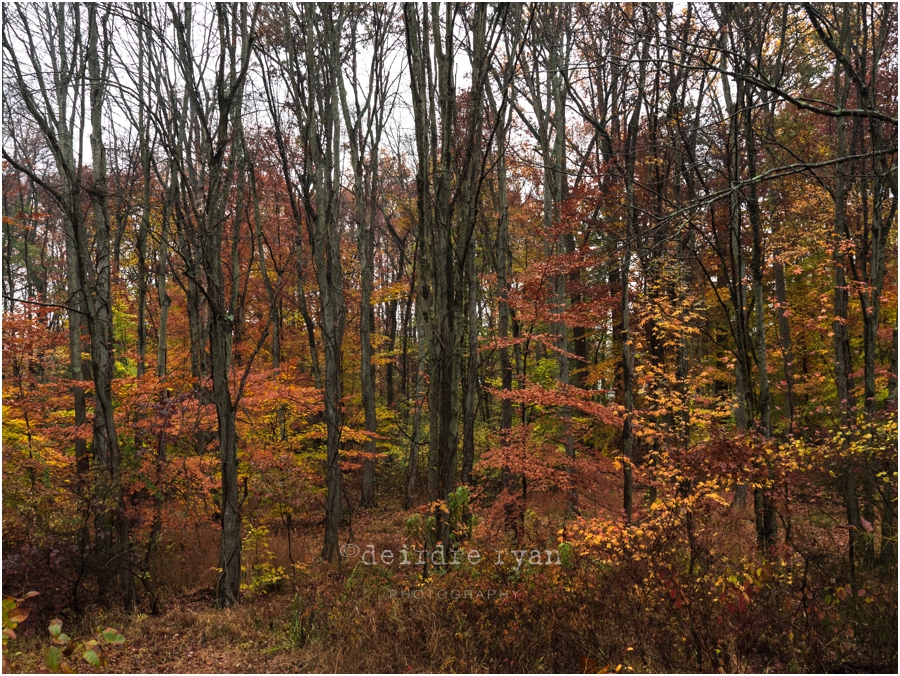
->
4, 496, 897, 673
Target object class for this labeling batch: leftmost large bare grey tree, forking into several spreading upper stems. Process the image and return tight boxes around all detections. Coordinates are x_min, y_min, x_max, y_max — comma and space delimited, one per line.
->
3, 4, 136, 609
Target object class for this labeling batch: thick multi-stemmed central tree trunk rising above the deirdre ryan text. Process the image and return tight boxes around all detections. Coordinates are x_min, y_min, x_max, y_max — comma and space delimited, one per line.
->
404, 4, 485, 548
